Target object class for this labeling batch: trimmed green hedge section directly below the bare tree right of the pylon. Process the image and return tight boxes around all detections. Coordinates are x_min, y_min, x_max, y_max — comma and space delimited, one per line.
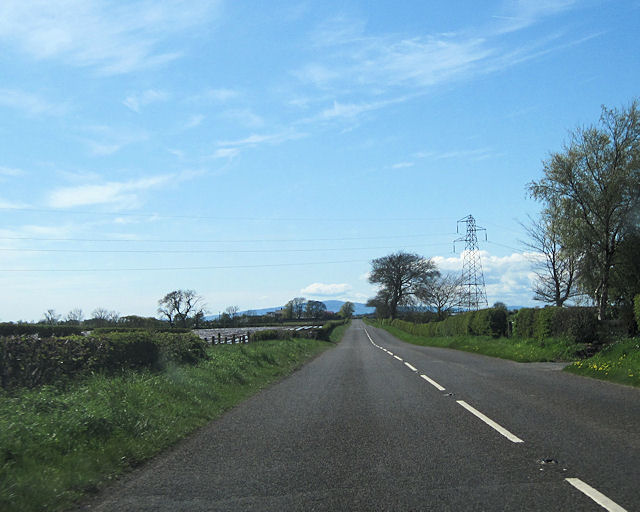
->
513, 306, 598, 343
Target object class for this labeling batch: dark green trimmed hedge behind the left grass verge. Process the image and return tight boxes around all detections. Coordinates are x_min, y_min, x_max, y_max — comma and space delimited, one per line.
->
0, 331, 207, 388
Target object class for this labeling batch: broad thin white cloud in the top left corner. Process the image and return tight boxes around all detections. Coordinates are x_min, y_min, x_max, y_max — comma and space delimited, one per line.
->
0, 0, 220, 74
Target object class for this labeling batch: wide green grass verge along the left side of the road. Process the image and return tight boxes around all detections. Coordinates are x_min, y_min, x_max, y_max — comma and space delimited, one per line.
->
0, 338, 336, 512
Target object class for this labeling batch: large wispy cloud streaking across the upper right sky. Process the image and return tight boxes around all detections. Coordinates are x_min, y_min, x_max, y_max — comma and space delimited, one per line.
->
292, 4, 591, 120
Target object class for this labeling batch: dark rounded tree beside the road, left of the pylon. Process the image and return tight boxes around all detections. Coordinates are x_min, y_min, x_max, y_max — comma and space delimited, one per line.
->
369, 251, 439, 318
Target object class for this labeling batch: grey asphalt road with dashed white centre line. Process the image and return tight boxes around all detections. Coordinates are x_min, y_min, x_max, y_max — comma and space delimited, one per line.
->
83, 321, 640, 512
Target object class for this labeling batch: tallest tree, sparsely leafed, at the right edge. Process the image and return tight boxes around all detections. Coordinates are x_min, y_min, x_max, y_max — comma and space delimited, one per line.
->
529, 100, 640, 320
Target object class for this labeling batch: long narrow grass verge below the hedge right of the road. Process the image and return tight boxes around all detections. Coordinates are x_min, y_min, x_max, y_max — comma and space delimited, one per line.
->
368, 321, 585, 363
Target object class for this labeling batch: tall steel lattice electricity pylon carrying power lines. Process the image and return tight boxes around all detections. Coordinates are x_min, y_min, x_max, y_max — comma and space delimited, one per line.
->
453, 215, 489, 311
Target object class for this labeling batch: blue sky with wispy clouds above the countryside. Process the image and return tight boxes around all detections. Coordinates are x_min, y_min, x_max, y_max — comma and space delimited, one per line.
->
0, 0, 640, 321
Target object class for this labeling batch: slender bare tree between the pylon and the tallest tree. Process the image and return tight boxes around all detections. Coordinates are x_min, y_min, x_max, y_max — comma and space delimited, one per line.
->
523, 210, 579, 306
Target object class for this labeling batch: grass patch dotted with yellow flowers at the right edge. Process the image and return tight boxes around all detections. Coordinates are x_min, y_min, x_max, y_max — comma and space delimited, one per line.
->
565, 338, 640, 387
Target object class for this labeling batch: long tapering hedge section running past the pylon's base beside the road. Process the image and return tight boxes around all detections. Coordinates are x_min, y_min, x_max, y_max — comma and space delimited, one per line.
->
384, 308, 508, 338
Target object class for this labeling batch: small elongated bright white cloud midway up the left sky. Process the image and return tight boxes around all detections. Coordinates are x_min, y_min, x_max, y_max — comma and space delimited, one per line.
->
48, 175, 174, 208
